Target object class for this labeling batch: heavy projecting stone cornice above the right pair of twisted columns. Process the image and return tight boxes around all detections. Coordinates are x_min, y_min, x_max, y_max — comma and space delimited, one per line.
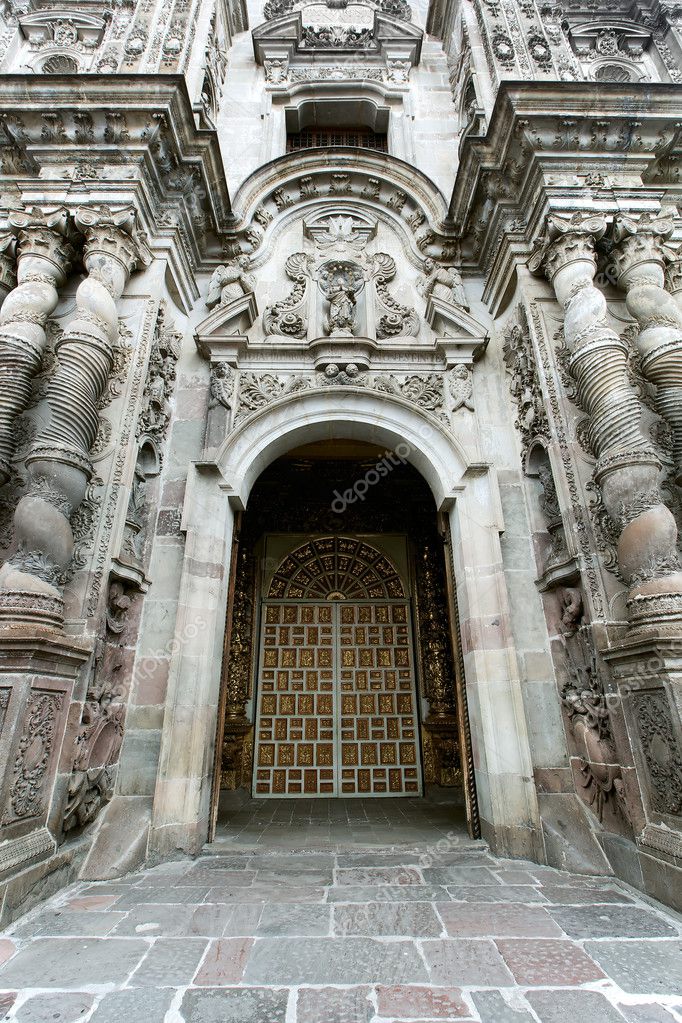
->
449, 82, 682, 306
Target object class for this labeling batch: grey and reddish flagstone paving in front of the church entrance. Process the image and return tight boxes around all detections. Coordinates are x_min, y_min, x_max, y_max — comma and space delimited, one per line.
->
0, 807, 682, 1023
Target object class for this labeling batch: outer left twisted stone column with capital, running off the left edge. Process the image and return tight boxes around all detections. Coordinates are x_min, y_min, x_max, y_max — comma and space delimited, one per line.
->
0, 208, 74, 486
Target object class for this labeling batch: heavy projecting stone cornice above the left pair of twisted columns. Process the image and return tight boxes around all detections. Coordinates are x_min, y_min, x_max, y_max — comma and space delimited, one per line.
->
0, 75, 231, 272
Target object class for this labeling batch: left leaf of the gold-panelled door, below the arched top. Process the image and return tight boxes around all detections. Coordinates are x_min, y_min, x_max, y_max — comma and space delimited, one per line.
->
254, 603, 335, 796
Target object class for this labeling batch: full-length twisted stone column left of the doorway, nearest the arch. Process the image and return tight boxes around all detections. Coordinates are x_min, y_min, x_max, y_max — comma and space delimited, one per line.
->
0, 207, 149, 625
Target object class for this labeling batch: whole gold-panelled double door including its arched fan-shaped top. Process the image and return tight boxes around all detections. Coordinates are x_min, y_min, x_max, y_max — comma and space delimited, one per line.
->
254, 537, 421, 798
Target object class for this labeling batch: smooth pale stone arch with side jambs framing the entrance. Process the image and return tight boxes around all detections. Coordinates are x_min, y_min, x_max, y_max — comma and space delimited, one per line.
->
150, 387, 544, 859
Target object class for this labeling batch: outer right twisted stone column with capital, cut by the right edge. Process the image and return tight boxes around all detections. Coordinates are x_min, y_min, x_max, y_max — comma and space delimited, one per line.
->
611, 213, 682, 485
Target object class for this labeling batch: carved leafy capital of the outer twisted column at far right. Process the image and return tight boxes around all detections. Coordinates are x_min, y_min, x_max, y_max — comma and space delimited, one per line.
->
611, 210, 675, 287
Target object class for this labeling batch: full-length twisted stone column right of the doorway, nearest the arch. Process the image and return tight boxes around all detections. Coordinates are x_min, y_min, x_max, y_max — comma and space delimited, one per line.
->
530, 214, 682, 627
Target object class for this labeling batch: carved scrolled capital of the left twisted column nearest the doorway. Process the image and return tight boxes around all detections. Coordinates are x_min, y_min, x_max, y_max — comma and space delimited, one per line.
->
74, 206, 151, 297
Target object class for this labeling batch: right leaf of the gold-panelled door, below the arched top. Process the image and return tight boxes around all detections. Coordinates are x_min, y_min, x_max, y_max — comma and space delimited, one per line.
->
336, 604, 421, 796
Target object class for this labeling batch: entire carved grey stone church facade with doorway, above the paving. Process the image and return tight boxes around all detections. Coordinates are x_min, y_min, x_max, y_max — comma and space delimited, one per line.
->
0, 0, 682, 923
